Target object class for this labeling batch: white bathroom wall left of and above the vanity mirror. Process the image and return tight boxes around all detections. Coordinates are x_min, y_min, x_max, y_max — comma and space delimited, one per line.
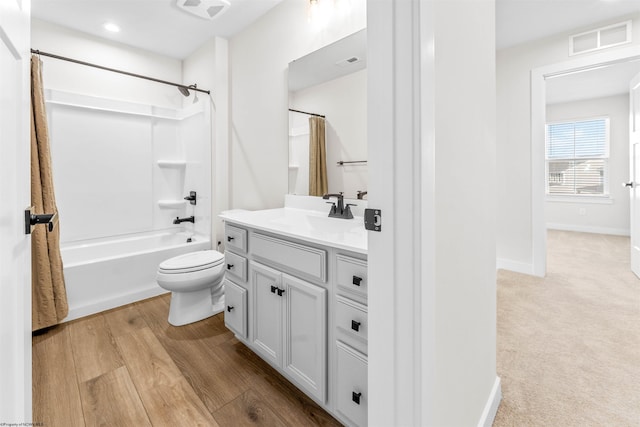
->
229, 0, 366, 209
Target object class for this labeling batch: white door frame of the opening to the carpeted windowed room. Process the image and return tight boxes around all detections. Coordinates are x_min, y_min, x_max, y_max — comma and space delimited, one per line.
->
531, 46, 640, 277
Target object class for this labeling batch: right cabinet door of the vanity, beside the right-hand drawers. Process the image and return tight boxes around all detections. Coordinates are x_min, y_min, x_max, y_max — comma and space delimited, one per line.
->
282, 274, 327, 402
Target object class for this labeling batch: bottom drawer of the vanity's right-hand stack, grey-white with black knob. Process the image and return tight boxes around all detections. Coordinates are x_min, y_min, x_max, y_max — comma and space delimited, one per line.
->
336, 341, 369, 426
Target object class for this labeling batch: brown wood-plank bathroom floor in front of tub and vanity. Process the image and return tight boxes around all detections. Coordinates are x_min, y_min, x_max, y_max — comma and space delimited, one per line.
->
33, 295, 340, 427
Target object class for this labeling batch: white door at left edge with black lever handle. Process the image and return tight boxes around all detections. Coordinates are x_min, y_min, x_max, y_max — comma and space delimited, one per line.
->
0, 0, 31, 424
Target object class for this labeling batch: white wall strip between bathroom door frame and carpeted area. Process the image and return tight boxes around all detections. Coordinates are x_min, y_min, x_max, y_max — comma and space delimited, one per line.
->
434, 1, 499, 426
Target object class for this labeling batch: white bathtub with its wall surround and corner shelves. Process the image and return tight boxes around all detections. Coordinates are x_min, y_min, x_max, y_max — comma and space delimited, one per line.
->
48, 90, 211, 320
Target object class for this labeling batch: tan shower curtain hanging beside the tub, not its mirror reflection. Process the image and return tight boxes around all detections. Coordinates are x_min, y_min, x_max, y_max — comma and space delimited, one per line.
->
31, 55, 69, 331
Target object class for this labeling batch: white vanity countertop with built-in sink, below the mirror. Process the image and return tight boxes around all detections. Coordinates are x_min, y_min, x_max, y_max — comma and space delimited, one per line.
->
220, 207, 367, 254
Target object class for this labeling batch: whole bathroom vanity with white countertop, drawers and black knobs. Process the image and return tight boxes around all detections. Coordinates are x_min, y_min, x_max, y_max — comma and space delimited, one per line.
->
221, 200, 368, 426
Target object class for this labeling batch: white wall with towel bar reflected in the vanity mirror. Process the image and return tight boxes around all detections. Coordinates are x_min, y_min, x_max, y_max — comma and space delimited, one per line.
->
289, 69, 368, 199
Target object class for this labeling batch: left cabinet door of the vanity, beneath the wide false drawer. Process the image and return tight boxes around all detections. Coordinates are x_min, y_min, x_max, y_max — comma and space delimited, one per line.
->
250, 262, 284, 366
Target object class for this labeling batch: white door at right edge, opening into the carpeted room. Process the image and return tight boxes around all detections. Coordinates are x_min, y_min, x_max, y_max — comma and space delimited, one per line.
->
627, 74, 640, 277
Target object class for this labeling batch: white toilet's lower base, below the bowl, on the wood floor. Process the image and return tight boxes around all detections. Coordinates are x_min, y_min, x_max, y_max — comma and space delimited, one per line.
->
169, 288, 224, 326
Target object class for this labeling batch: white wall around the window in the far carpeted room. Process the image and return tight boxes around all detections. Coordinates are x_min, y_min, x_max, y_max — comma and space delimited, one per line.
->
545, 95, 629, 236
